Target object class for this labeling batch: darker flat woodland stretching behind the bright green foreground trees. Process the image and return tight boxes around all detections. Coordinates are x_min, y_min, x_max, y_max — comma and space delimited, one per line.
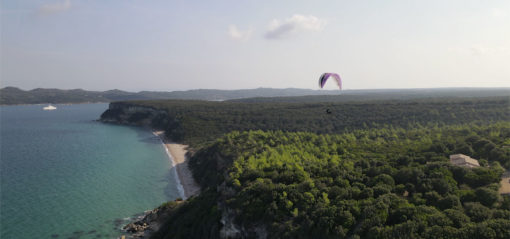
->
123, 96, 510, 148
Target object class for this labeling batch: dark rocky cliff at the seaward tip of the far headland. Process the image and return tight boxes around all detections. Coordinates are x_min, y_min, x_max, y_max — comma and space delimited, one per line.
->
100, 102, 169, 128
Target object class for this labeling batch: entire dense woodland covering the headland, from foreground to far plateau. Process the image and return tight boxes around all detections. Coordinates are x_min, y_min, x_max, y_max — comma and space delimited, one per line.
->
99, 97, 510, 238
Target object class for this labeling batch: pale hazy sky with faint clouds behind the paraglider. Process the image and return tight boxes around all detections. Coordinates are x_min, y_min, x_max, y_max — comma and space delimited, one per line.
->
0, 0, 510, 91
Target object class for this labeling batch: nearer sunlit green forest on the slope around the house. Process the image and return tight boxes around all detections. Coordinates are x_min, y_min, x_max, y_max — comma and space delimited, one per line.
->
153, 122, 510, 238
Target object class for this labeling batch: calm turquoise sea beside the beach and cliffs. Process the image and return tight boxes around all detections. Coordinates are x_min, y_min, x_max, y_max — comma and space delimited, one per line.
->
0, 104, 179, 239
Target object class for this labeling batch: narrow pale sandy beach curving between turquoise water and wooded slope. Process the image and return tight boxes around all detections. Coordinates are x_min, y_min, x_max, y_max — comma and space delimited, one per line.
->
154, 131, 200, 199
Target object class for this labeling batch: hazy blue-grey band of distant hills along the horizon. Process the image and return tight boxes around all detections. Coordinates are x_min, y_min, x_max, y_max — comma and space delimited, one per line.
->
0, 87, 510, 105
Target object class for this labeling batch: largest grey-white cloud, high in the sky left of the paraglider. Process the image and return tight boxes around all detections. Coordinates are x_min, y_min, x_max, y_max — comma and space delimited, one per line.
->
265, 14, 326, 39
